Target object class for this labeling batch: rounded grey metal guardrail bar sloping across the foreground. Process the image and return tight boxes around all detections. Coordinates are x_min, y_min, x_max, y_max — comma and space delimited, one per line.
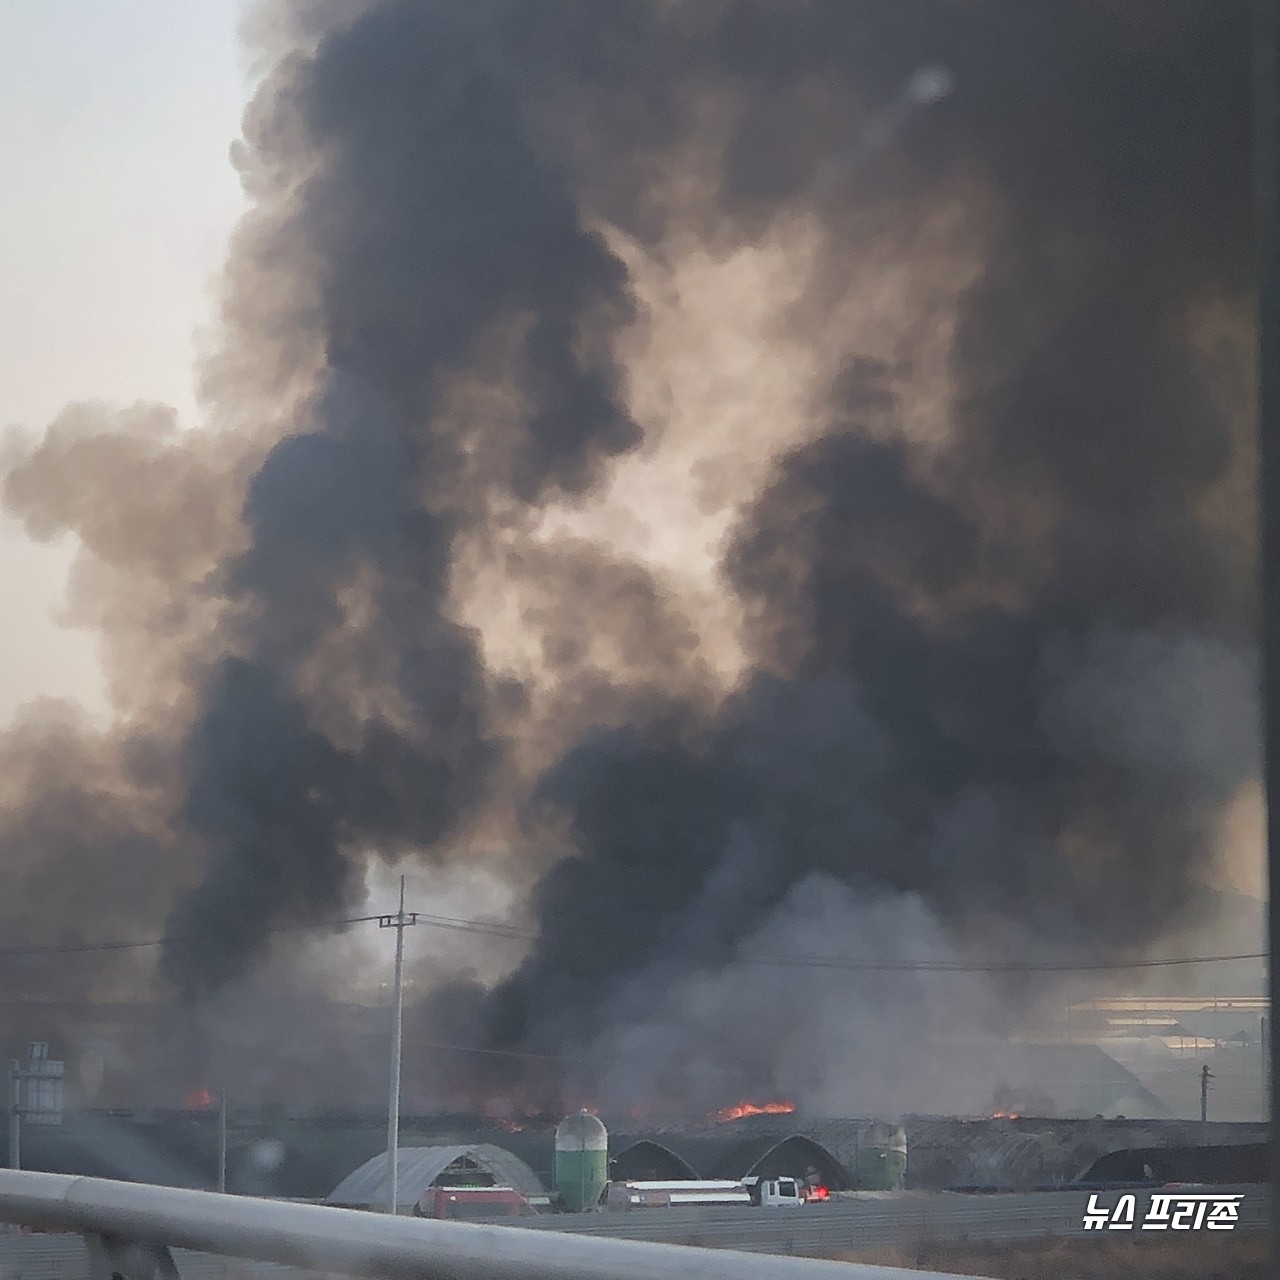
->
0, 1170, 983, 1280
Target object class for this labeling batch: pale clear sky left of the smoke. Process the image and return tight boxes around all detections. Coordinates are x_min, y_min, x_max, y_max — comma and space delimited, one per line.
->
0, 0, 250, 724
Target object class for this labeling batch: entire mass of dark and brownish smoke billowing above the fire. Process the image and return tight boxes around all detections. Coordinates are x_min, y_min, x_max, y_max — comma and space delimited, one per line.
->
0, 0, 1257, 1121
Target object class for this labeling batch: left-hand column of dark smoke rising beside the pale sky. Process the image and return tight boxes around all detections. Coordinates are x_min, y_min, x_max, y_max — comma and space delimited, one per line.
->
164, 3, 639, 993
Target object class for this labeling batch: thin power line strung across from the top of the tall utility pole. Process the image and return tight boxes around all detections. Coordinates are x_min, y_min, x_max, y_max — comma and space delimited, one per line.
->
0, 911, 1268, 973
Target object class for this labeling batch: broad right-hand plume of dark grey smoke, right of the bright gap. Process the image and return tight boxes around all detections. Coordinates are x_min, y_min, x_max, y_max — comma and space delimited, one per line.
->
424, 4, 1257, 1097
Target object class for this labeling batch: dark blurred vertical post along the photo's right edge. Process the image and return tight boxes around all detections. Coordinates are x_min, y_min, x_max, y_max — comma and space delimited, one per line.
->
1253, 0, 1280, 1247
